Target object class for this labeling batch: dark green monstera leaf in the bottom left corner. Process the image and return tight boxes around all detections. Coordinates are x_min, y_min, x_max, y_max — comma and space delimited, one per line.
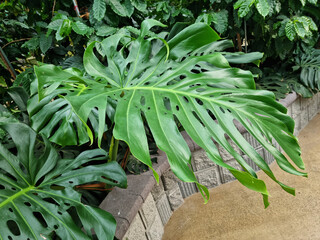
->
0, 119, 126, 240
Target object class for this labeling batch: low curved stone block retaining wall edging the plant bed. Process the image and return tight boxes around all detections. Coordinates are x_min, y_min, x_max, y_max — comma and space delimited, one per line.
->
100, 93, 320, 240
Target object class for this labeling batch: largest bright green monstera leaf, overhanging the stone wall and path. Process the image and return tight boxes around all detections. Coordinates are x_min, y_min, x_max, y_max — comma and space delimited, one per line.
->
36, 20, 306, 206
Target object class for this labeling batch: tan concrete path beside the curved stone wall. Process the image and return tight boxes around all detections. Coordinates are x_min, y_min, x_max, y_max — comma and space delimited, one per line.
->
163, 114, 320, 240
